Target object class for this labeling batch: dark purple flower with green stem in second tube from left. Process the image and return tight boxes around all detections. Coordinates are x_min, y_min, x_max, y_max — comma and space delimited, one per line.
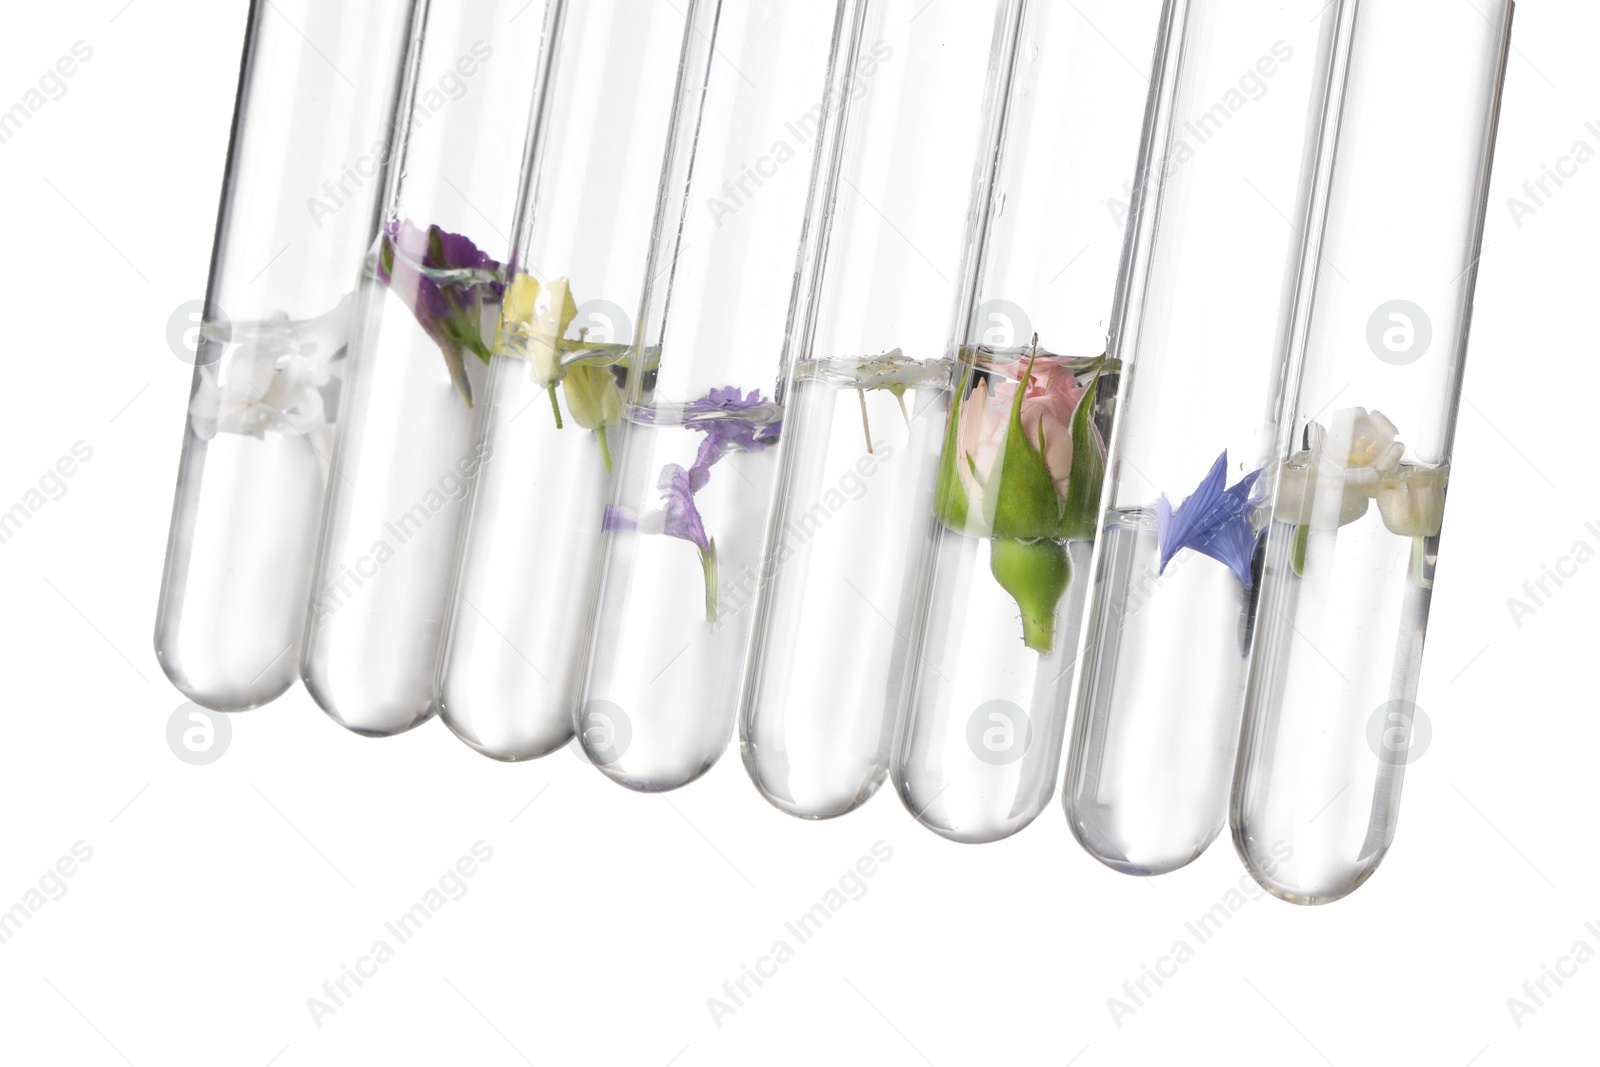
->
378, 219, 506, 405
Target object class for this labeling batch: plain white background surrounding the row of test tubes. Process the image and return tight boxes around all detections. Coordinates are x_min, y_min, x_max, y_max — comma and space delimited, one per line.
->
0, 0, 1600, 1067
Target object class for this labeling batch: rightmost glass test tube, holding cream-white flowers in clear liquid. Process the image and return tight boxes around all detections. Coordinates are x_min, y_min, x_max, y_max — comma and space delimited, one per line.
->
1232, 0, 1512, 904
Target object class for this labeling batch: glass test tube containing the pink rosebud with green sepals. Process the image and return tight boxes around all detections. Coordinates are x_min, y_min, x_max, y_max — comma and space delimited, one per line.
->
891, 0, 1162, 841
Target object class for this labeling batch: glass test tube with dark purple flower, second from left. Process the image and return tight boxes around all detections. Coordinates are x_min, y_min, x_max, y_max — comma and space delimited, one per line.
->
301, 0, 556, 736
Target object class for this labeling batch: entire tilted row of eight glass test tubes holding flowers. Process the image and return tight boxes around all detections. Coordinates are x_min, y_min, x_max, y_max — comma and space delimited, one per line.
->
155, 0, 1512, 904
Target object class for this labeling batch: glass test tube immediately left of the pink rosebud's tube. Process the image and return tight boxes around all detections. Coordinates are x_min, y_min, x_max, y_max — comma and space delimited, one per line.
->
739, 0, 1021, 817
